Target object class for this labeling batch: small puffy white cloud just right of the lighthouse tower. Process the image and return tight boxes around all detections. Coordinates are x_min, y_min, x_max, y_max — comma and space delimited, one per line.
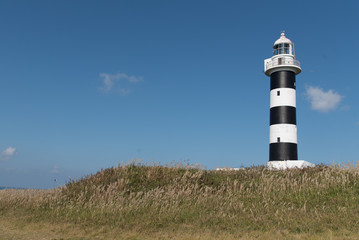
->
306, 86, 343, 112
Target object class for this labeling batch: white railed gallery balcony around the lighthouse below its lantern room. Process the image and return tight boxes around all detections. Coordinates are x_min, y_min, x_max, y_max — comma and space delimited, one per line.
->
264, 55, 302, 76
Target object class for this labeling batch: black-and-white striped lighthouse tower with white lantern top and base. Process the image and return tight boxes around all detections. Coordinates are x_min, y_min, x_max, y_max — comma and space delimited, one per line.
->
264, 32, 314, 169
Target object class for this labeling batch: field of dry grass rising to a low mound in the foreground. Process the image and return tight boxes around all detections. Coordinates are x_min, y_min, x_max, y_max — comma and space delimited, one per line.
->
0, 164, 359, 240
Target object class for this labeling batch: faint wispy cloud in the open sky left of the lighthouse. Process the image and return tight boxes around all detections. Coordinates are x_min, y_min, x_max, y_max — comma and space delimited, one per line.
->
100, 73, 143, 95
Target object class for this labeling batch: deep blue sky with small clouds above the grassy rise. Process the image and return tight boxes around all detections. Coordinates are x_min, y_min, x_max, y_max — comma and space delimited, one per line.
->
0, 0, 359, 188
